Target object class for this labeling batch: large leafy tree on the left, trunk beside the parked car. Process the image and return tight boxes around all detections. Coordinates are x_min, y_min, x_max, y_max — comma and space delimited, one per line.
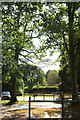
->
2, 2, 42, 103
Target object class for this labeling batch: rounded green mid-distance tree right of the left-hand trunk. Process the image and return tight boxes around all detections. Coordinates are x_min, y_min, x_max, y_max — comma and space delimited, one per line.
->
21, 64, 45, 92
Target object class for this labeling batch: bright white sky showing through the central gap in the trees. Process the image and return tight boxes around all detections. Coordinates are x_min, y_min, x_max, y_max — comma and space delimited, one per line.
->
33, 38, 60, 73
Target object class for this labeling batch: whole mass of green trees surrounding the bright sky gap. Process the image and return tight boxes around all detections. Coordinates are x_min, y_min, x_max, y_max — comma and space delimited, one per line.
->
2, 2, 80, 103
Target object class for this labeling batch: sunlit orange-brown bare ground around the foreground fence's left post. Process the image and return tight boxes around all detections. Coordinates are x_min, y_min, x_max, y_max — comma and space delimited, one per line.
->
0, 104, 61, 120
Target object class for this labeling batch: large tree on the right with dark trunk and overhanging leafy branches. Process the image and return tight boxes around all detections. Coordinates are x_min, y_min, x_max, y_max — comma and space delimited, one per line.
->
37, 2, 80, 100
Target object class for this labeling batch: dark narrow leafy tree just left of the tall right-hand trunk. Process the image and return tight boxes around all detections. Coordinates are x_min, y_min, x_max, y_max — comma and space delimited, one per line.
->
59, 41, 71, 92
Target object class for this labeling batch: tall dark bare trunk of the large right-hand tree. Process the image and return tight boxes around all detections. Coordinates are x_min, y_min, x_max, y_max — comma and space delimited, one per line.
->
68, 3, 78, 100
